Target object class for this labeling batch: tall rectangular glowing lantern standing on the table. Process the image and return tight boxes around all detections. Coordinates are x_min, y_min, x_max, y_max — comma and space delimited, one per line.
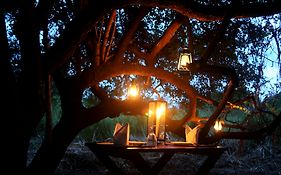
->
147, 101, 167, 142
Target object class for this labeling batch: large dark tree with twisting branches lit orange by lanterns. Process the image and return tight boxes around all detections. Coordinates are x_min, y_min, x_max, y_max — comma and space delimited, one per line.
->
0, 0, 281, 174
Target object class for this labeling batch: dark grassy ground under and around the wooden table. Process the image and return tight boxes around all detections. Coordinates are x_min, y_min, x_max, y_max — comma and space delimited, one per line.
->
26, 141, 281, 175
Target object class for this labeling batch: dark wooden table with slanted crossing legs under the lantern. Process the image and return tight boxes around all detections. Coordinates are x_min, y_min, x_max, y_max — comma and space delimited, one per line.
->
85, 142, 226, 175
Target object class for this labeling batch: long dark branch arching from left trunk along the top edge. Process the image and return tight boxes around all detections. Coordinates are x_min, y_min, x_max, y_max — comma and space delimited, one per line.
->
47, 0, 281, 72
